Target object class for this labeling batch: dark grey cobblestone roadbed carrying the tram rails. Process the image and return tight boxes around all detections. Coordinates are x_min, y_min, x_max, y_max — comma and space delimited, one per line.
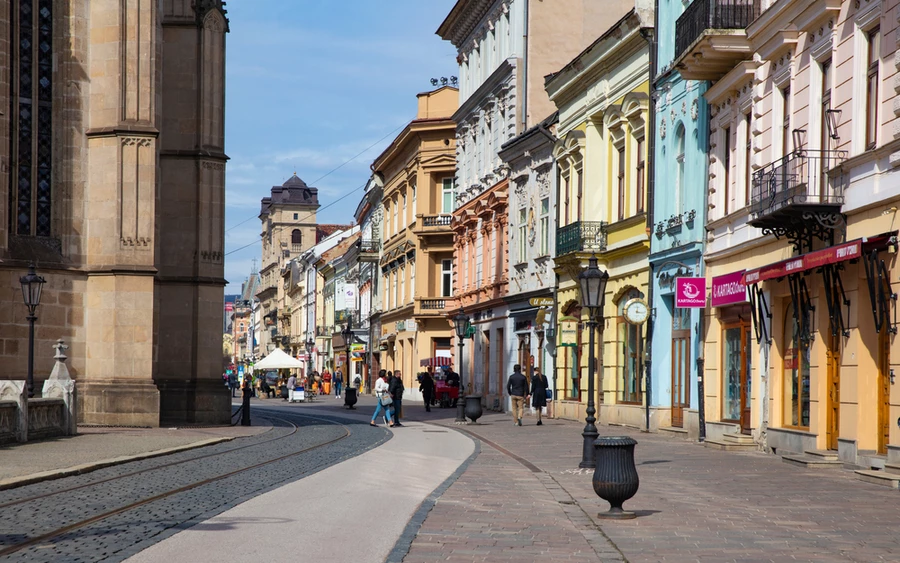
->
0, 411, 390, 562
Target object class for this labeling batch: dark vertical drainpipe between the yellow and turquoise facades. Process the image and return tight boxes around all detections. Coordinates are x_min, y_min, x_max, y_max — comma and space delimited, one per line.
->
641, 18, 659, 432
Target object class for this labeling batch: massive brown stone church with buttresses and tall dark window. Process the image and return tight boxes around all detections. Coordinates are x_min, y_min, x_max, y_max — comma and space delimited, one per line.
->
0, 0, 236, 426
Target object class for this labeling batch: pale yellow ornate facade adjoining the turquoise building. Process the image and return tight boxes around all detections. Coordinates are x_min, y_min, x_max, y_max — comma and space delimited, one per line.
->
547, 10, 653, 425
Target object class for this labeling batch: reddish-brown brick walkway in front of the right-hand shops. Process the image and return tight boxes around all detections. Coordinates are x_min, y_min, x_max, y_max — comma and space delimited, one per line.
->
394, 405, 900, 563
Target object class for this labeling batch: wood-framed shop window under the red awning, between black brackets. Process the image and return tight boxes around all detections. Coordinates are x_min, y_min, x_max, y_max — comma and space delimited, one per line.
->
782, 305, 810, 430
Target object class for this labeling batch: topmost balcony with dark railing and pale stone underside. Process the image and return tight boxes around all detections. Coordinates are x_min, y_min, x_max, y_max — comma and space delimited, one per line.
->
675, 0, 761, 80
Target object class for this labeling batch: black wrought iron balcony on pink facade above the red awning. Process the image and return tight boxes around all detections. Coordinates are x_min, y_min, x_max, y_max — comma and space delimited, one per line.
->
750, 150, 849, 253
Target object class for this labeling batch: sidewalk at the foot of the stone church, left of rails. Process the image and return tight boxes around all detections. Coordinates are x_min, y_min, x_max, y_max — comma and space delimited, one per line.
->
0, 406, 272, 490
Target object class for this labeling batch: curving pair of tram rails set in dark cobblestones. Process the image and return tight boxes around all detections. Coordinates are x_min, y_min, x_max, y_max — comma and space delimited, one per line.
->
0, 415, 353, 558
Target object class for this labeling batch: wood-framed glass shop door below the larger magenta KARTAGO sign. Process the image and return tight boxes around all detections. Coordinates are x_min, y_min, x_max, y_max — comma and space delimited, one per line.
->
722, 320, 751, 434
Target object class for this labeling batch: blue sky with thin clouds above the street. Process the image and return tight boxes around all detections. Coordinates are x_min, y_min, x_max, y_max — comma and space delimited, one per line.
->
219, 0, 458, 294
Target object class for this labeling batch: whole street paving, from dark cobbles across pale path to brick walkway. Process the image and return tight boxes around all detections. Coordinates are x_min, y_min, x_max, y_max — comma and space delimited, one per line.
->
0, 397, 900, 563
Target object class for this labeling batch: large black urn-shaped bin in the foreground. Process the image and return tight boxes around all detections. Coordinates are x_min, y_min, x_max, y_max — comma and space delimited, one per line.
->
593, 436, 640, 520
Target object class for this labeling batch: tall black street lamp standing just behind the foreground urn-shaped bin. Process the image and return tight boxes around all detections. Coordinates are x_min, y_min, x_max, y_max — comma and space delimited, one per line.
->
578, 256, 609, 468
